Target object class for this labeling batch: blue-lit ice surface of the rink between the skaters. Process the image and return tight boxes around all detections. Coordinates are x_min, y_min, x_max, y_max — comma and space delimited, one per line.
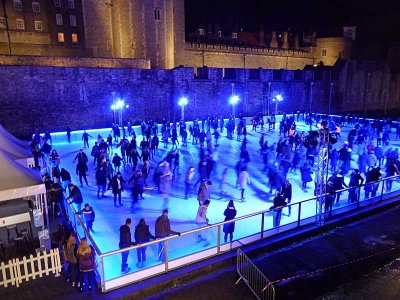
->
45, 116, 399, 278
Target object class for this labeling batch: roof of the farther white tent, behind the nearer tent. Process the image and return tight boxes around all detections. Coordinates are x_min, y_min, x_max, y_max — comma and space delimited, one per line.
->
0, 126, 35, 168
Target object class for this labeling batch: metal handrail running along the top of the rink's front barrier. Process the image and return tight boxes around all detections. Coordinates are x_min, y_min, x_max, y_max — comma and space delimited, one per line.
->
98, 175, 400, 257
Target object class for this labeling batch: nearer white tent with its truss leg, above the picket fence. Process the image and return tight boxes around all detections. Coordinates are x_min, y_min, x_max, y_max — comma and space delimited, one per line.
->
0, 149, 49, 244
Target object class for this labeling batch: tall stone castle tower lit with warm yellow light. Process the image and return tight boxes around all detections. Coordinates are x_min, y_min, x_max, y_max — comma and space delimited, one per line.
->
83, 0, 185, 69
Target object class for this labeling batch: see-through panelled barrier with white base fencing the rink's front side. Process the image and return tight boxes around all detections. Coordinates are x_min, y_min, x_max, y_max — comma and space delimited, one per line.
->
67, 176, 400, 292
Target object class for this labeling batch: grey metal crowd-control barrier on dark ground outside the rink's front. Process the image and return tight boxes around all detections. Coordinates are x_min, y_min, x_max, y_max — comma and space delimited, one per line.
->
235, 248, 275, 300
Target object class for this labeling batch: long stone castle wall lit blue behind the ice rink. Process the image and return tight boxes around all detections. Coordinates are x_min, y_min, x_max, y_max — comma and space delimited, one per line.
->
0, 62, 400, 137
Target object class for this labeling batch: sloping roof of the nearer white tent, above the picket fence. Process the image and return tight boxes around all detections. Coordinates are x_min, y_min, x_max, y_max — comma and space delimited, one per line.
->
0, 149, 45, 201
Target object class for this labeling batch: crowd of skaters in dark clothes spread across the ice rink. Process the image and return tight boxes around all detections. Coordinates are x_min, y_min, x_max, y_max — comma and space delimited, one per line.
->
27, 113, 400, 284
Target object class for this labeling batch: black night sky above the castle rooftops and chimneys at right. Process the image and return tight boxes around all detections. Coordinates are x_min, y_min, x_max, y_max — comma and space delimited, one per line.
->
185, 0, 400, 41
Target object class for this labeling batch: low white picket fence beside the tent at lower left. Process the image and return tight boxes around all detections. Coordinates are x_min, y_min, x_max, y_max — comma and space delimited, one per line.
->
0, 249, 61, 287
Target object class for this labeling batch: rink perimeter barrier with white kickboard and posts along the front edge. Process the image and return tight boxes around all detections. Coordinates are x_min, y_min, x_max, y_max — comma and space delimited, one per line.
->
65, 176, 400, 292
